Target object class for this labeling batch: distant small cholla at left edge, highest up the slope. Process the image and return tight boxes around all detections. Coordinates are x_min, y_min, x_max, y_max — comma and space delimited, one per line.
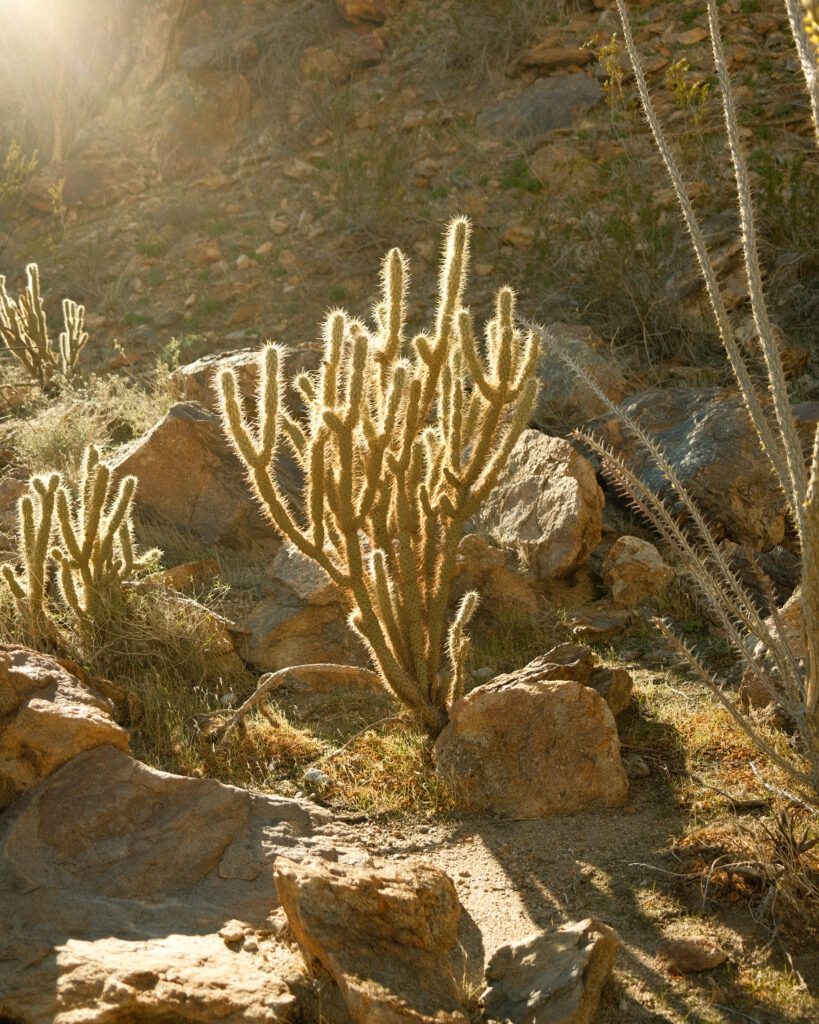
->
0, 263, 88, 391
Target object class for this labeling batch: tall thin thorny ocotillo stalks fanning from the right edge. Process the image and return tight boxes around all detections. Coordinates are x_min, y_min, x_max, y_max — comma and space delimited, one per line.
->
540, 0, 819, 801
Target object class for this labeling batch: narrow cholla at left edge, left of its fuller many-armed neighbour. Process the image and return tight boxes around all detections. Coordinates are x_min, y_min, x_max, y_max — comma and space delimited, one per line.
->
2, 473, 60, 636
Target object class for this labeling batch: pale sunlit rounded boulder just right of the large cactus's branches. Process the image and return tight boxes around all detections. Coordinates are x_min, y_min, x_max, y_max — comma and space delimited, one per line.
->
481, 430, 603, 579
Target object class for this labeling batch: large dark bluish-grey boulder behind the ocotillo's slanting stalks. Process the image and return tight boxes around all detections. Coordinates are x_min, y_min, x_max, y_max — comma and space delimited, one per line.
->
586, 388, 785, 551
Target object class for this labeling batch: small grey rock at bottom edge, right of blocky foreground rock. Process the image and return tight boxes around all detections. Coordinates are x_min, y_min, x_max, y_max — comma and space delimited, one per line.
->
483, 918, 619, 1024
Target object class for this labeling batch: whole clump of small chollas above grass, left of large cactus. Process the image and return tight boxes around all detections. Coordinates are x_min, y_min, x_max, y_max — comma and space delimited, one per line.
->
1, 445, 157, 640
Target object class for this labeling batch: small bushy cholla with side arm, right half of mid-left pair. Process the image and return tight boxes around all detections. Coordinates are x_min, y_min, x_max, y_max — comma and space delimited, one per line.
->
51, 444, 153, 620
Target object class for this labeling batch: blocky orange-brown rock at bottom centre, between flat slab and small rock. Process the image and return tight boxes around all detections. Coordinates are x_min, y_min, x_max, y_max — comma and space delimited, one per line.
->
275, 859, 467, 1024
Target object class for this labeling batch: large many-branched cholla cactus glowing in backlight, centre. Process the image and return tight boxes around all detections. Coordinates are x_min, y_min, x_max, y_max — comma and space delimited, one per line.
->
219, 218, 537, 735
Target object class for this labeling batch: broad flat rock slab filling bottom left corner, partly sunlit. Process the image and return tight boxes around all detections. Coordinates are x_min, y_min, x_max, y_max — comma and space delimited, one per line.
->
0, 746, 363, 1024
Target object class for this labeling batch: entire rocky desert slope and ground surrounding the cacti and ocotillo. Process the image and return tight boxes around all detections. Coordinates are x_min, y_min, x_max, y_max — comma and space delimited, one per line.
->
0, 0, 819, 1024
